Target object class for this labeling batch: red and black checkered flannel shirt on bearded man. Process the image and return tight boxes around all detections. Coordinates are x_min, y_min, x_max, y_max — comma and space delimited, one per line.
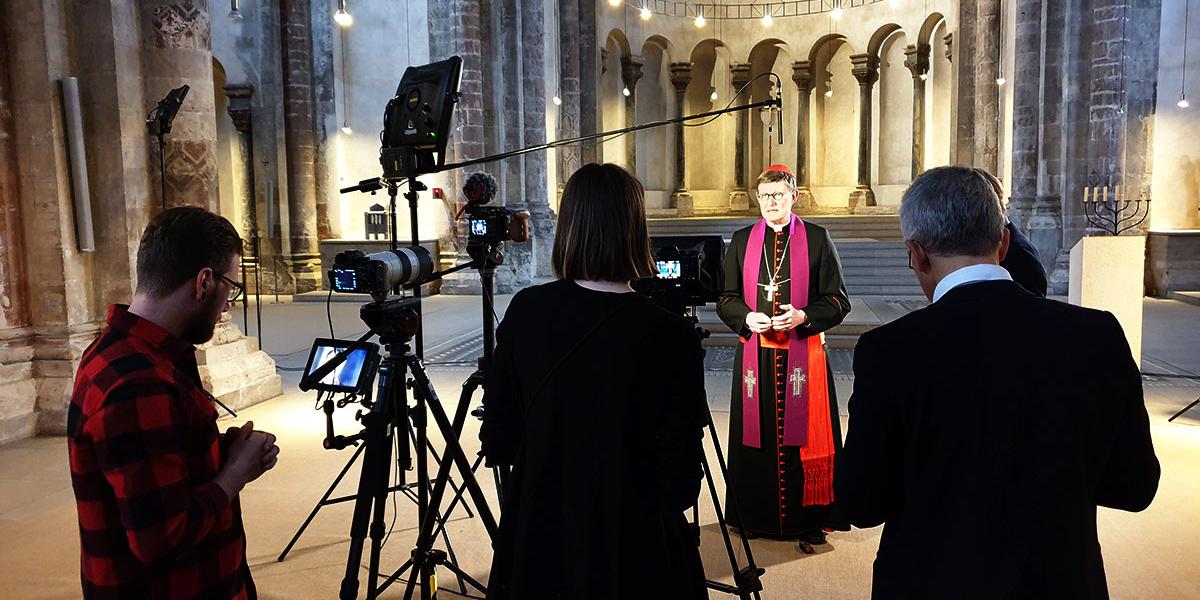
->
67, 305, 256, 599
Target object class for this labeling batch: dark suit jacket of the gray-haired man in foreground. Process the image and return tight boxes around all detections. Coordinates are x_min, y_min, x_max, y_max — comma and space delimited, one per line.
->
835, 281, 1159, 599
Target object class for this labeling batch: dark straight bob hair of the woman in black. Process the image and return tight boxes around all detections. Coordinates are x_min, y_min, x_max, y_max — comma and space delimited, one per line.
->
552, 163, 655, 281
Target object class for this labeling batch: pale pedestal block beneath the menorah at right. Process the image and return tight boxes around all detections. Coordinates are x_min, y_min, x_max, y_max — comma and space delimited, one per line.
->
1068, 235, 1146, 366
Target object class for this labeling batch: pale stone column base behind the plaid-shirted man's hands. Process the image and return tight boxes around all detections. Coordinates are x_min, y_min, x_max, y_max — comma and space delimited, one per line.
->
196, 313, 283, 410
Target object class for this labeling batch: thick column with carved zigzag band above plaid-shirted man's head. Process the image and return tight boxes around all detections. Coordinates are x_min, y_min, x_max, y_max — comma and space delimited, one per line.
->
140, 0, 218, 212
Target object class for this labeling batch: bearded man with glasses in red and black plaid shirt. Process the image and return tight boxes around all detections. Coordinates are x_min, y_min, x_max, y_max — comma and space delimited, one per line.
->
67, 208, 278, 599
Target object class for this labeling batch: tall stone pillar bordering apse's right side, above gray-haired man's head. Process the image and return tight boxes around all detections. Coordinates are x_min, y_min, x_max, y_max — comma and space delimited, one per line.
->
962, 0, 1001, 176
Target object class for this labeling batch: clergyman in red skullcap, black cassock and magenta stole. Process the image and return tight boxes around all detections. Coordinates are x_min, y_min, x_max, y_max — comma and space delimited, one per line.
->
718, 164, 850, 553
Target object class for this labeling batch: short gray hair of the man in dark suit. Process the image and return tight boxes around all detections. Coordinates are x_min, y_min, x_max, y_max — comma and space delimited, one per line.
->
900, 167, 1004, 257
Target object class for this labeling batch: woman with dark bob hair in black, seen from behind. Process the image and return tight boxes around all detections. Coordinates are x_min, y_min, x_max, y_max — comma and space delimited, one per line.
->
480, 164, 707, 600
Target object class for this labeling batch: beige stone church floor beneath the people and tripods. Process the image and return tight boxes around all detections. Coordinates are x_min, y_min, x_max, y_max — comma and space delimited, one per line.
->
0, 296, 1200, 599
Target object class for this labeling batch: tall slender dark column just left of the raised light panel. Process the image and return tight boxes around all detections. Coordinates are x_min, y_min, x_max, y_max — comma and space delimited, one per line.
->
278, 0, 329, 294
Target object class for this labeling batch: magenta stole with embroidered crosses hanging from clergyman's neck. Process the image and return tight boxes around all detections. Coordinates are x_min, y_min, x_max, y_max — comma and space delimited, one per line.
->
740, 215, 811, 448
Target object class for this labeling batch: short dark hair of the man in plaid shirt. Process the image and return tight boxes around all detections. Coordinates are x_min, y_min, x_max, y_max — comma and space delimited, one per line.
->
138, 206, 242, 298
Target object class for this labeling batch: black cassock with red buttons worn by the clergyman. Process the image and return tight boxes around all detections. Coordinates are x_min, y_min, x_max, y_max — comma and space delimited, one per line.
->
716, 222, 850, 539
